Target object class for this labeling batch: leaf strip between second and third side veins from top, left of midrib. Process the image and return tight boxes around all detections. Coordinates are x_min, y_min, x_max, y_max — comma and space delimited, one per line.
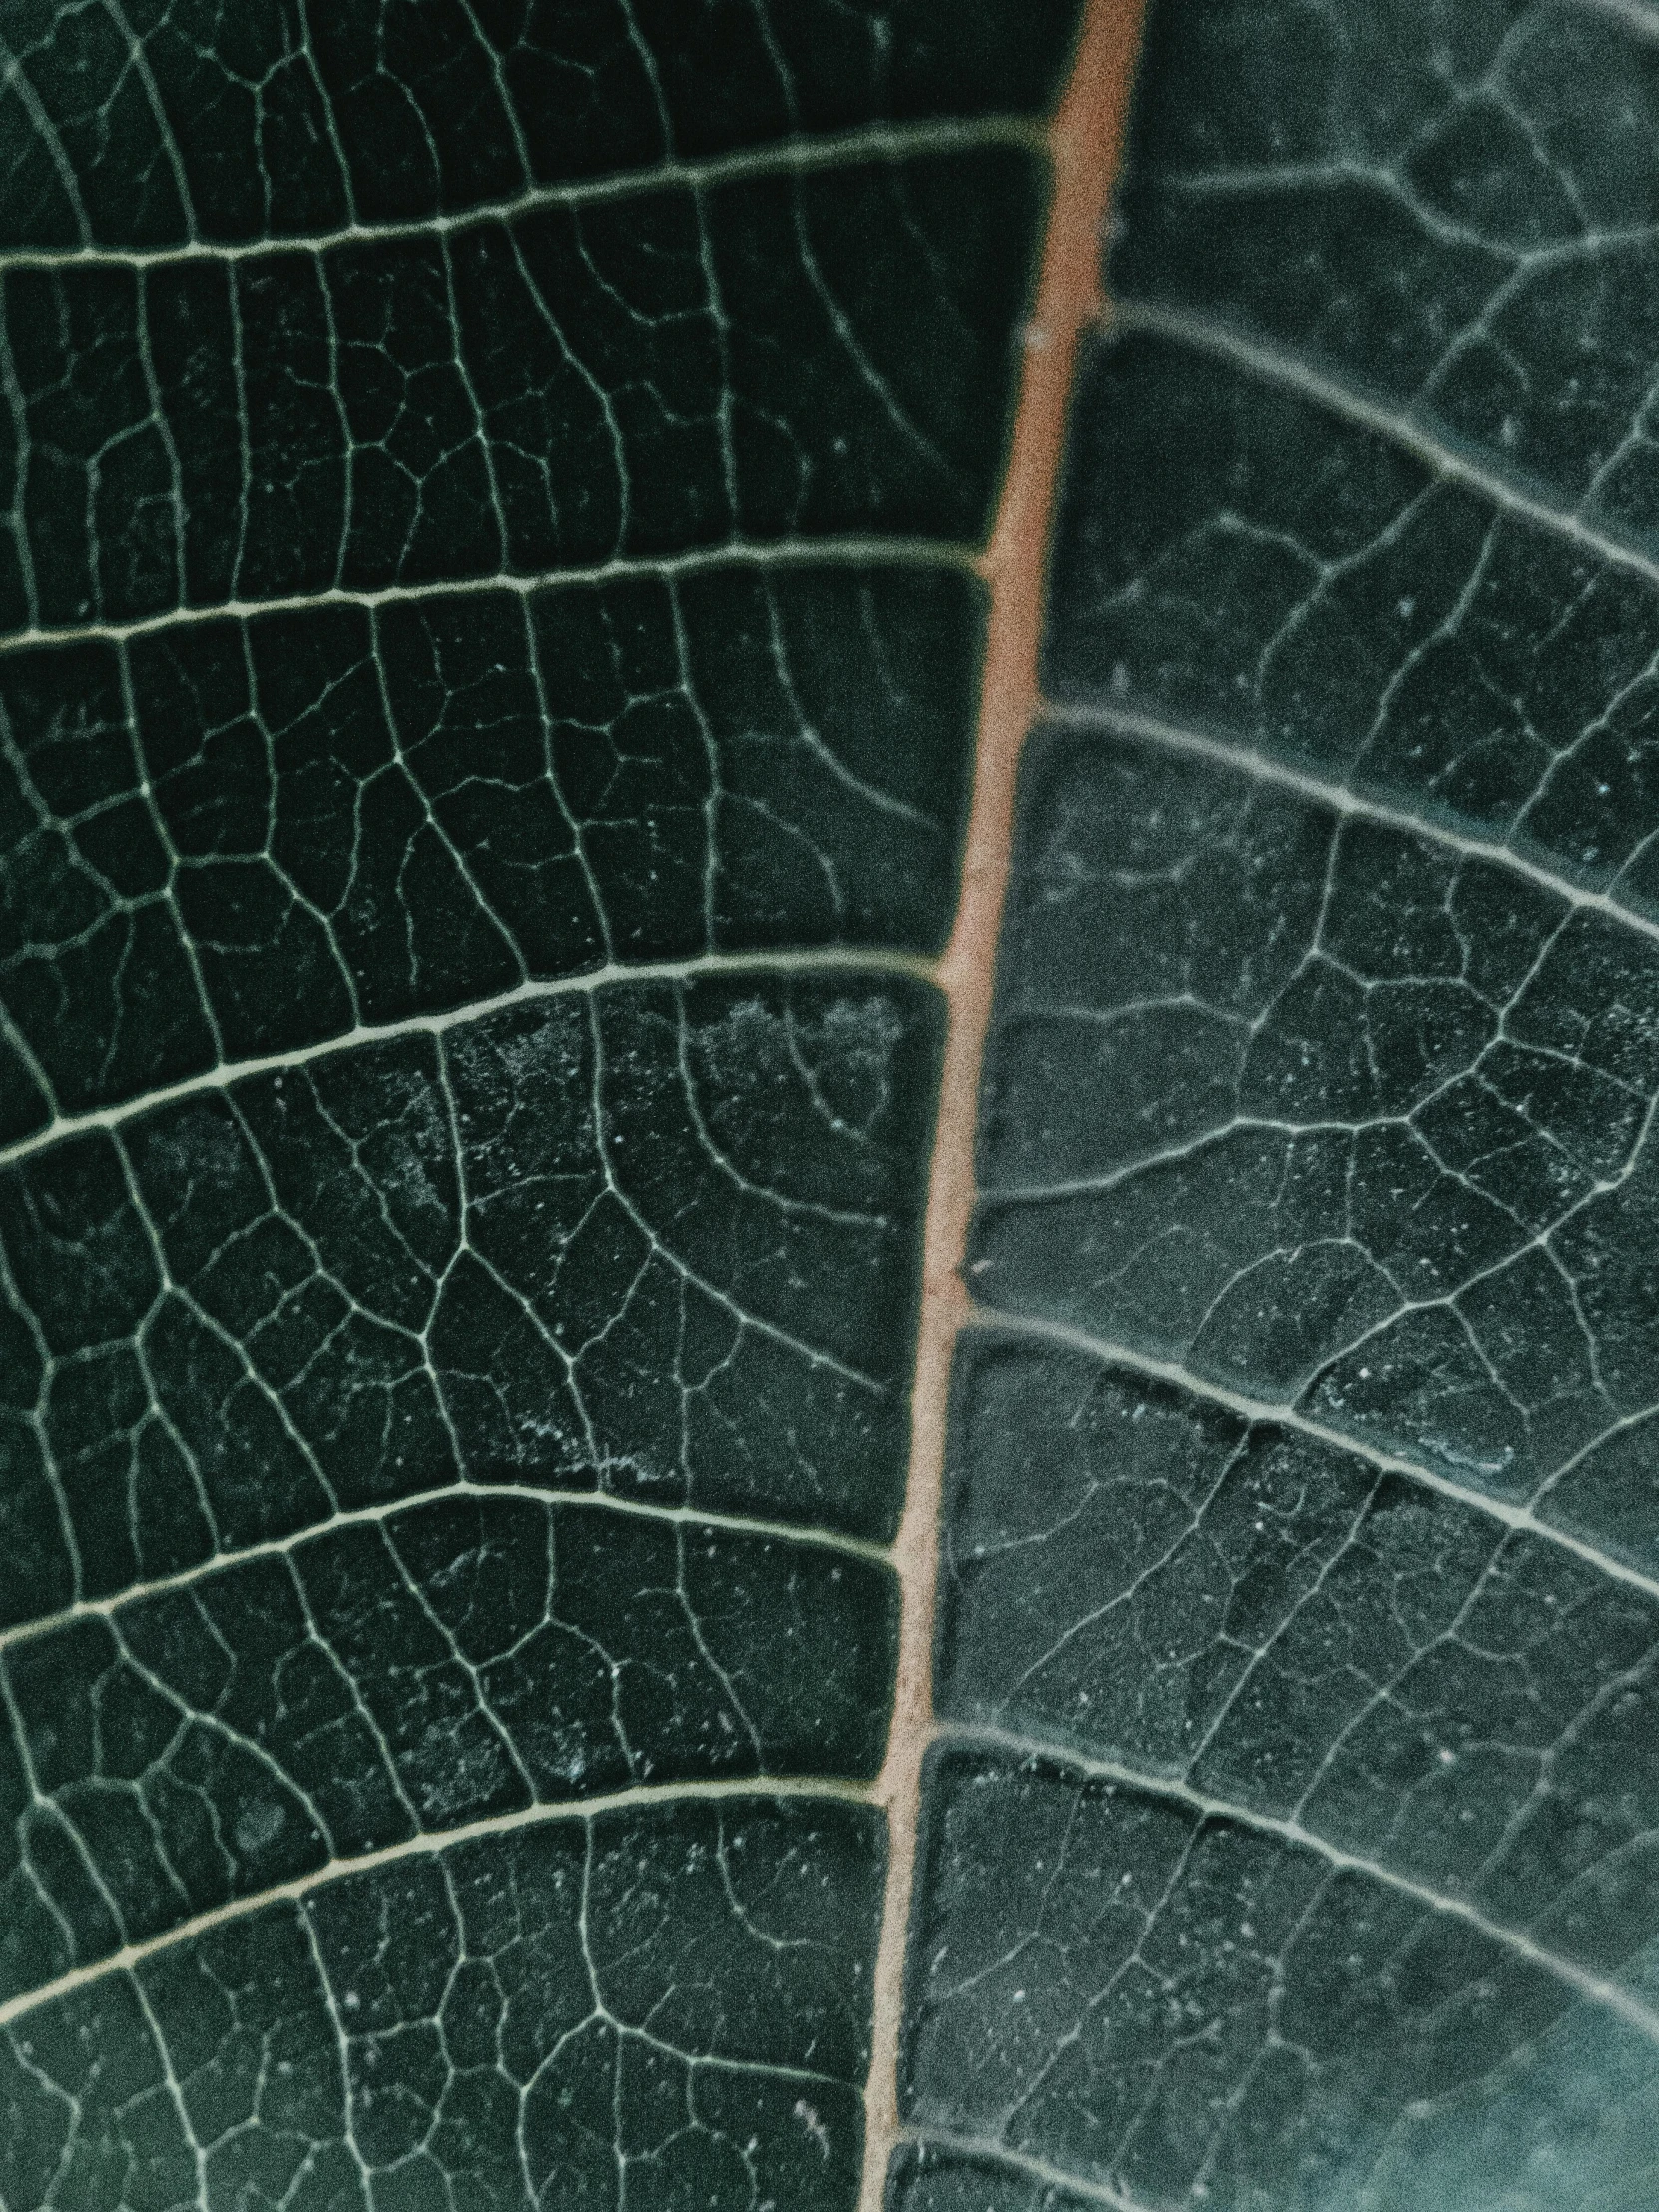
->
0, 562, 982, 1139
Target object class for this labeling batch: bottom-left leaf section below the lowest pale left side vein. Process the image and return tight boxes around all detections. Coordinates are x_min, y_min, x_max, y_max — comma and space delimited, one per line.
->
0, 1796, 897, 2212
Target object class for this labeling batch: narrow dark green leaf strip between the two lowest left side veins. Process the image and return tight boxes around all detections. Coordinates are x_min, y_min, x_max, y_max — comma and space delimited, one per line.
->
0, 1495, 895, 2001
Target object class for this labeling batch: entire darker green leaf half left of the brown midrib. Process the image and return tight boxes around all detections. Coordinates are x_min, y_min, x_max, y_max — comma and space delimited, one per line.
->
0, 0, 1073, 2212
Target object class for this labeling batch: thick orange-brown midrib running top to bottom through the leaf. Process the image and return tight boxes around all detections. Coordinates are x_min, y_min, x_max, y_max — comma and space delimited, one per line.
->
858, 0, 1144, 2212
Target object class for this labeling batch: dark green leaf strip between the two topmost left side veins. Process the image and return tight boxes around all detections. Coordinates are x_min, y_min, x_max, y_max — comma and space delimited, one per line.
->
0, 146, 1037, 631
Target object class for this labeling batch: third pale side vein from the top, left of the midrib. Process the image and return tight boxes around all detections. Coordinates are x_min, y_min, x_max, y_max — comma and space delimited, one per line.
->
0, 946, 933, 1168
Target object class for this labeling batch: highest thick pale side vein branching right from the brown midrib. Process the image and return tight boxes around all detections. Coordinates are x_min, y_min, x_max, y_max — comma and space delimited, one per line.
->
1113, 300, 1659, 586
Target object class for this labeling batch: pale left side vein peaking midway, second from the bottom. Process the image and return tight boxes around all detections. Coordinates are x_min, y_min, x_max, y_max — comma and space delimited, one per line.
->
0, 1475, 893, 1652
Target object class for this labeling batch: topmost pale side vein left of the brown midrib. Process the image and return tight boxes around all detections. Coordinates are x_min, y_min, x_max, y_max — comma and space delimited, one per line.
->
0, 115, 1044, 270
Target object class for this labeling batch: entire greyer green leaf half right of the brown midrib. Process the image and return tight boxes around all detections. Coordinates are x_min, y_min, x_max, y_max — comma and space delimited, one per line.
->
895, 0, 1659, 2212
